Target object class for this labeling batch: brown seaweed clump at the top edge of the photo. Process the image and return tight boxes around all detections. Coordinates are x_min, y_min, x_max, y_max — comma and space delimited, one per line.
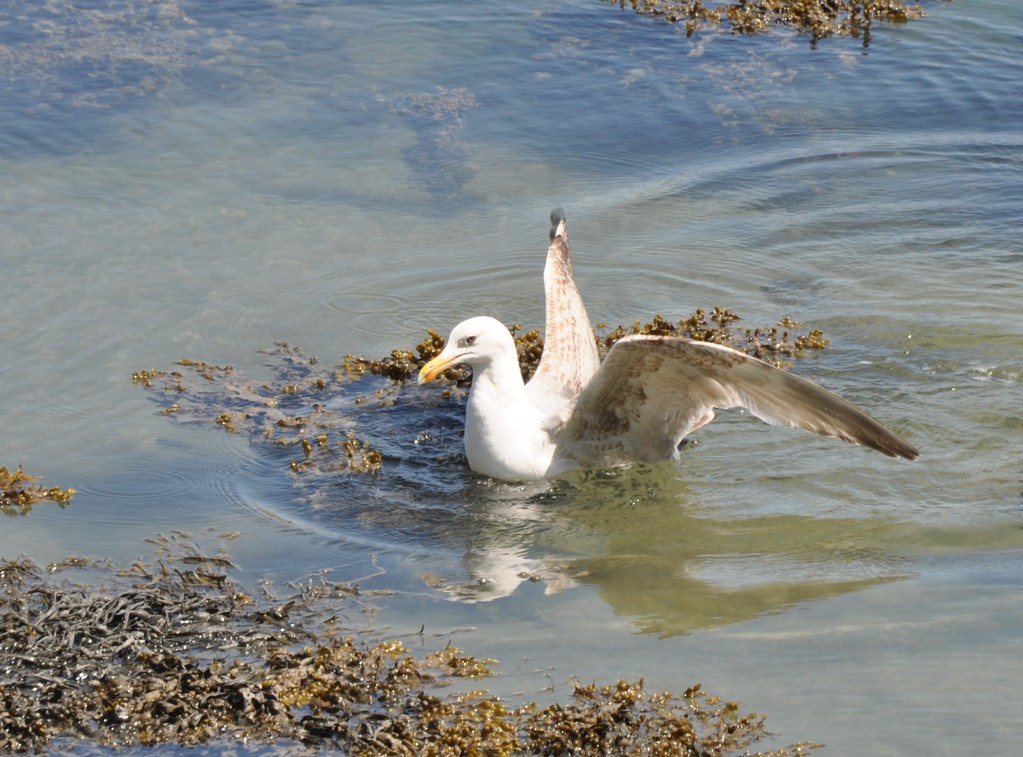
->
607, 0, 924, 47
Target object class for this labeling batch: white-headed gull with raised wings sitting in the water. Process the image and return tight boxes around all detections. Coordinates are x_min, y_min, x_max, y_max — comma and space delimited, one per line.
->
418, 208, 920, 481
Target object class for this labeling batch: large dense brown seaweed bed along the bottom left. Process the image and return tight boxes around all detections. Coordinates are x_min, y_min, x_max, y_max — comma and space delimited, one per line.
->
0, 535, 814, 756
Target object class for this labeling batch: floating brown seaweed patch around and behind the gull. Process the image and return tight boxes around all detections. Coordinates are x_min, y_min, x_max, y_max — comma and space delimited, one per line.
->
132, 308, 828, 475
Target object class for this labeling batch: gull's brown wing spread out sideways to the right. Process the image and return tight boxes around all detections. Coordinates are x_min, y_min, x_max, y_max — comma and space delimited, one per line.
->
559, 336, 919, 462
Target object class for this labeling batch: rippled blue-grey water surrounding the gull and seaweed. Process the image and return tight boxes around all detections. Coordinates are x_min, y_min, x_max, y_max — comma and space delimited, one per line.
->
0, 0, 1023, 754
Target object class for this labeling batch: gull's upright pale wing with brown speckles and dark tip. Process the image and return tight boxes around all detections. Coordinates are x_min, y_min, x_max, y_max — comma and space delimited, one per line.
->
526, 208, 601, 415
